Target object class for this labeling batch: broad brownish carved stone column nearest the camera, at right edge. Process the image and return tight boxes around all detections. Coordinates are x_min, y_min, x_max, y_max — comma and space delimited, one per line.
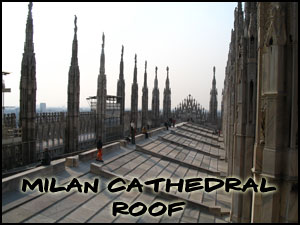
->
252, 2, 298, 223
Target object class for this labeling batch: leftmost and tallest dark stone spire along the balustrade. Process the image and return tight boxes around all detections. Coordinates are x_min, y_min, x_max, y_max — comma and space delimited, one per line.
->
19, 2, 36, 164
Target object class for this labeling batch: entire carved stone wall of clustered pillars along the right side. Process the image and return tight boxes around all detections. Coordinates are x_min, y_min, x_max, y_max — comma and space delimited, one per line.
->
222, 2, 298, 222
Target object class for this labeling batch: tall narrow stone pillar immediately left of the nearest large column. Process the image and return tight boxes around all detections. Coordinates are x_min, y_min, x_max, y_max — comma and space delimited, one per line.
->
231, 2, 251, 222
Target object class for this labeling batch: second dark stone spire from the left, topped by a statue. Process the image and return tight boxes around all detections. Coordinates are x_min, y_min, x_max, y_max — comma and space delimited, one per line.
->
65, 16, 80, 153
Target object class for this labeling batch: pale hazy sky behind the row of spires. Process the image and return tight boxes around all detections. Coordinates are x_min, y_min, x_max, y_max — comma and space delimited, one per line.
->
2, 2, 237, 110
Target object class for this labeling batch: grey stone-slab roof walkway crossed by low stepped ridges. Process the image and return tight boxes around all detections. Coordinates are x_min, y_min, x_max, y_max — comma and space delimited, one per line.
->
2, 124, 231, 223
